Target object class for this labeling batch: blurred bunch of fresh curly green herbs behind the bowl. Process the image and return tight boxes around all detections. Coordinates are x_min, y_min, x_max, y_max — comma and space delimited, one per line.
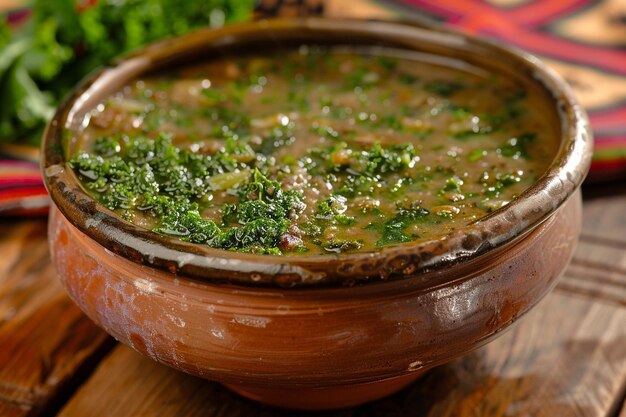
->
0, 0, 254, 144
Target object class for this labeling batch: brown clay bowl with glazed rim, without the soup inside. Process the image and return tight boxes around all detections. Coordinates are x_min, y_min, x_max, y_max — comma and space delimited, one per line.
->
43, 19, 592, 409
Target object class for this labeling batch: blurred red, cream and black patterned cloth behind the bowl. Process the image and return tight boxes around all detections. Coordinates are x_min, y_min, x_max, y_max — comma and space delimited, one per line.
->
0, 0, 626, 215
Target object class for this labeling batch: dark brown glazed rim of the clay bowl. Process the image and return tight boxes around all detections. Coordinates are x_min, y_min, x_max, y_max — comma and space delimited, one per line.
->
42, 18, 592, 287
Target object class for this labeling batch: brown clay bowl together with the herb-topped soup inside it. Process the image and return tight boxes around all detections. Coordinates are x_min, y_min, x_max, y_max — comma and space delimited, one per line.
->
43, 19, 591, 409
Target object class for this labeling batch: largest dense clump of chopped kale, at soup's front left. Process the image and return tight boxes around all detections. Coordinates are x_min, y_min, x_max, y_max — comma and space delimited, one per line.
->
70, 135, 306, 253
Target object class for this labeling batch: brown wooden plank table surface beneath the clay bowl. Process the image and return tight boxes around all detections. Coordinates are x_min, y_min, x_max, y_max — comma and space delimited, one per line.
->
0, 184, 626, 417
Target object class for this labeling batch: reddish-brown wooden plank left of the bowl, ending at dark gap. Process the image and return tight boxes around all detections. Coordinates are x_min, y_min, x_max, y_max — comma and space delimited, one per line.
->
0, 220, 111, 416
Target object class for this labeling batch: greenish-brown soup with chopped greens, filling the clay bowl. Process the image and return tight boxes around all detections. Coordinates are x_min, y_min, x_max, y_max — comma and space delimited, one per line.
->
70, 47, 558, 255
